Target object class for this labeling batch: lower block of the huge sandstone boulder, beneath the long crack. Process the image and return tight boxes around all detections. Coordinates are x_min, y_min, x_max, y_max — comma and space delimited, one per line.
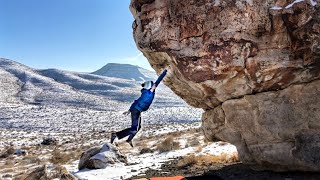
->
202, 80, 320, 171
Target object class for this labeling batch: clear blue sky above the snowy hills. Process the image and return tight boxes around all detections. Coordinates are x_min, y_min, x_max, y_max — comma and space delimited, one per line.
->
0, 0, 151, 72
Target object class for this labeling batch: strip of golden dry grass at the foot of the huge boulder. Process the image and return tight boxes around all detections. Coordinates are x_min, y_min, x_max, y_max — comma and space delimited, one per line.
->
177, 153, 239, 168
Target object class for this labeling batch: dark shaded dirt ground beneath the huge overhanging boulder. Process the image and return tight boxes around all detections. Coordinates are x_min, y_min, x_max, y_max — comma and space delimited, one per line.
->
131, 160, 320, 180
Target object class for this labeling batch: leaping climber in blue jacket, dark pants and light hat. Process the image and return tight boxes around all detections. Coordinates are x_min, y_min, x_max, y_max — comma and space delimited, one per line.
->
111, 70, 167, 147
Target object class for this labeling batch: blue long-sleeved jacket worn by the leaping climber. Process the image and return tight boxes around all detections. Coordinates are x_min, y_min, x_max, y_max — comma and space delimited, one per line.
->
130, 70, 167, 112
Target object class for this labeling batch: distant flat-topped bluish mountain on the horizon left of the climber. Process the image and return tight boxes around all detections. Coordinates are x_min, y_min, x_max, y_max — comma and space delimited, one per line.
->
92, 63, 157, 81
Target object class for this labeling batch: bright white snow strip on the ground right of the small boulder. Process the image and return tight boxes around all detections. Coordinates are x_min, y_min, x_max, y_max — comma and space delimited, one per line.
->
66, 134, 237, 180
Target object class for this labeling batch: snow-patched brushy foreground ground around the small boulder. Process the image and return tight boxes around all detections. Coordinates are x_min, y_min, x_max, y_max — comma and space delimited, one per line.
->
0, 127, 238, 180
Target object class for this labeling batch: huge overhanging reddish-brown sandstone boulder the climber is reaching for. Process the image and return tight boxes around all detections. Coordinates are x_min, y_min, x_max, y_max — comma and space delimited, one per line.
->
130, 0, 320, 171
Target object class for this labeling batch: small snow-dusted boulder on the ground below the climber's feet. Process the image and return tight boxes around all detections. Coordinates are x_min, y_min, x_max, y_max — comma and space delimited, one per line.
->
78, 143, 127, 170
